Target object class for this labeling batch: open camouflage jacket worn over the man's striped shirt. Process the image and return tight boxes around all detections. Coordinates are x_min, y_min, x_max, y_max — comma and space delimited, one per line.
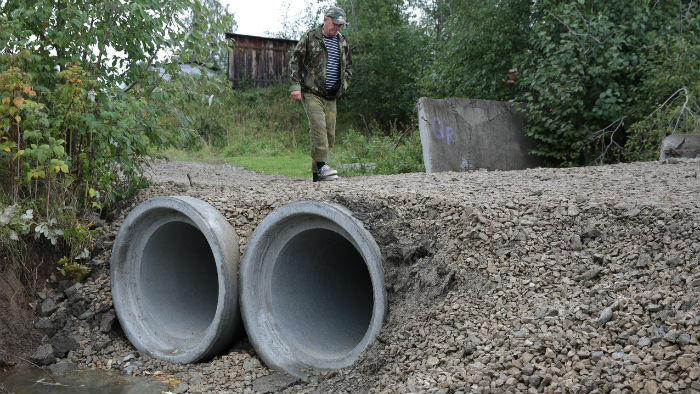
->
289, 27, 352, 99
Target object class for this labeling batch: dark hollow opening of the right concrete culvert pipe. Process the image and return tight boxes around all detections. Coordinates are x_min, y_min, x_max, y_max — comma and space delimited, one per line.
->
270, 229, 374, 359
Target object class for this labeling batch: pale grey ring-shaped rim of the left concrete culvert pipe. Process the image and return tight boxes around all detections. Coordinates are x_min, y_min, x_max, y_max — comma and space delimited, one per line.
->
110, 196, 240, 364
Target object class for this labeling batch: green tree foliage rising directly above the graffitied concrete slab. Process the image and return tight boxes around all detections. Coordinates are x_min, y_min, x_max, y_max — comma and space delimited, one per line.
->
421, 0, 530, 100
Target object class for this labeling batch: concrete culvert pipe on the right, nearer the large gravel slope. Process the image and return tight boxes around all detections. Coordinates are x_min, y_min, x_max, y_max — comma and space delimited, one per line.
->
240, 201, 387, 378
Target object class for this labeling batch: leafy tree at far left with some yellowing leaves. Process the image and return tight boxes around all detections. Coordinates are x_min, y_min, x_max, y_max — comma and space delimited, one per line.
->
0, 0, 234, 212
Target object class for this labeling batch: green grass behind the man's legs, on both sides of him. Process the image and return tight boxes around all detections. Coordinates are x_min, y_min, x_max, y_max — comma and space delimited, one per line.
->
161, 86, 424, 178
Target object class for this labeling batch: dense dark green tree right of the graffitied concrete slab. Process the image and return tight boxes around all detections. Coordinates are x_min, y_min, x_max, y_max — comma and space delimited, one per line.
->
520, 0, 700, 165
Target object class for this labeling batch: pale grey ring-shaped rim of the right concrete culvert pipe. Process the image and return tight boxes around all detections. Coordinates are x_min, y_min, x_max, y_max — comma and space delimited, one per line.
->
239, 200, 387, 378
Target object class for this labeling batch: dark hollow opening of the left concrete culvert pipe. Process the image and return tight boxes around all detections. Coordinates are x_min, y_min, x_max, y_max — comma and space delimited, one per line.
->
139, 221, 219, 348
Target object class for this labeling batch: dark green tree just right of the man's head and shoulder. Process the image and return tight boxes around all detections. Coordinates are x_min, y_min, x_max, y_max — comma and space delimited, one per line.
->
339, 0, 427, 128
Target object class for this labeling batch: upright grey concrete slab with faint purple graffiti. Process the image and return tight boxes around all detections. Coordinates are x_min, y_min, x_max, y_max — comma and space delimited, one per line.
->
417, 97, 540, 173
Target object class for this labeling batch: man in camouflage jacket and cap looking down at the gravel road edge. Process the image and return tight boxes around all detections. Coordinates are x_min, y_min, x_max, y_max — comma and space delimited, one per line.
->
289, 7, 352, 182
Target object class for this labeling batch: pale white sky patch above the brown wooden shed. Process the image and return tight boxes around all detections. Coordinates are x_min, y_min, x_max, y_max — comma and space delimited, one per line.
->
221, 0, 314, 36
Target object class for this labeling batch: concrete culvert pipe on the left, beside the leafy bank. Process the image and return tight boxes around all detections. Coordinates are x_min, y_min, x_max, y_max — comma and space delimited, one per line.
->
111, 196, 240, 363
